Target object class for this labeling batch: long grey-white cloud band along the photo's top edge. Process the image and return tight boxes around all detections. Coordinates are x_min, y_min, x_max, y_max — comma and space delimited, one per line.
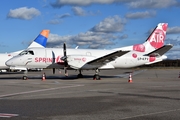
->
51, 0, 180, 8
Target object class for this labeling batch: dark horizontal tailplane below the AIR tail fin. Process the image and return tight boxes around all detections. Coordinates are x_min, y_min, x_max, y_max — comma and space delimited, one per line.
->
147, 44, 173, 57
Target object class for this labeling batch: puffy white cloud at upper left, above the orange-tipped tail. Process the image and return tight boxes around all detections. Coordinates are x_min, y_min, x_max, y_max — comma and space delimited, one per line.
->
7, 7, 41, 20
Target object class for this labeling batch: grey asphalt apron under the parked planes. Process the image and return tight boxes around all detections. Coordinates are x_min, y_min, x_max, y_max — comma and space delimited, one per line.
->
0, 69, 180, 120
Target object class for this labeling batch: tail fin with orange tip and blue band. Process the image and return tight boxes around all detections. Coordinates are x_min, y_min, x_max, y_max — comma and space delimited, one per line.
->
28, 30, 50, 48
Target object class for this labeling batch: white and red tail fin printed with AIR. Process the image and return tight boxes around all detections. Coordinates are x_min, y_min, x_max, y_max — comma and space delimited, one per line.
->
133, 23, 168, 52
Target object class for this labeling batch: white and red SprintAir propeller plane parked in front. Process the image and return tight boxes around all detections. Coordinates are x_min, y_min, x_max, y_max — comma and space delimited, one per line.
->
6, 23, 173, 80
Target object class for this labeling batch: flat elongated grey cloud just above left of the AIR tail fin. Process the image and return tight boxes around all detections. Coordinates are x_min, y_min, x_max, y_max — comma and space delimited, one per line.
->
125, 11, 156, 19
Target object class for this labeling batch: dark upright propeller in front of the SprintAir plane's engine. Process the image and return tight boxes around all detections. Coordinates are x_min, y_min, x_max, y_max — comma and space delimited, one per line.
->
61, 43, 68, 76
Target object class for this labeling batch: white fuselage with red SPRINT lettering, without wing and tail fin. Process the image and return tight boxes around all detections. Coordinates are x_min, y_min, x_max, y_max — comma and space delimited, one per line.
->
6, 48, 167, 69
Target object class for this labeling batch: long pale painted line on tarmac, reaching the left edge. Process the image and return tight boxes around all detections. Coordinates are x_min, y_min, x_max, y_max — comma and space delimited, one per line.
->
0, 85, 84, 98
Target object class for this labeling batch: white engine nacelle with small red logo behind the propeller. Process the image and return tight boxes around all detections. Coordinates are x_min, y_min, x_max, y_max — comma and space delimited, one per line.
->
67, 55, 95, 69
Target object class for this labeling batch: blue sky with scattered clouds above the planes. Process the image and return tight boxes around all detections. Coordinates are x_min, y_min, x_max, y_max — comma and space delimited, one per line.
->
0, 0, 180, 59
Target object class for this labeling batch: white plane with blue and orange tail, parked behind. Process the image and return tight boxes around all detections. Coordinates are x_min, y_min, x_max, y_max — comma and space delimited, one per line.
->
0, 30, 49, 70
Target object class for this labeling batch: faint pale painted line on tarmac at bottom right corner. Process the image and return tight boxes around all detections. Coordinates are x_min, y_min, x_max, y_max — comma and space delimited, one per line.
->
120, 109, 180, 120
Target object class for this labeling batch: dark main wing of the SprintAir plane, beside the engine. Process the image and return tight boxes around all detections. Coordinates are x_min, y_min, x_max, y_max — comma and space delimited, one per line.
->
86, 50, 129, 65
